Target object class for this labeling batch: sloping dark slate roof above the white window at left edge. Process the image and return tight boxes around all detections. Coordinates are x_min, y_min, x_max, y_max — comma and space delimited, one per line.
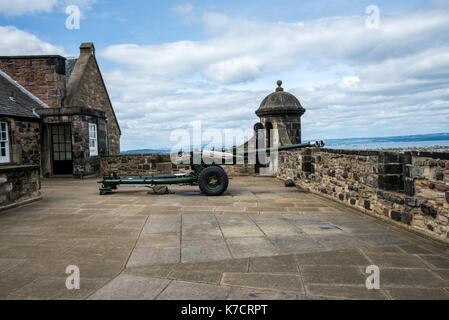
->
0, 70, 48, 118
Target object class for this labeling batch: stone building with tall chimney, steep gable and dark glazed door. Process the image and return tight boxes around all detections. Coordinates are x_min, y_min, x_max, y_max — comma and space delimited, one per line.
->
0, 43, 121, 177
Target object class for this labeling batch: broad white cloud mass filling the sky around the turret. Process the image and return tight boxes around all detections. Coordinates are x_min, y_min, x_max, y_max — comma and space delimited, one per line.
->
101, 5, 449, 149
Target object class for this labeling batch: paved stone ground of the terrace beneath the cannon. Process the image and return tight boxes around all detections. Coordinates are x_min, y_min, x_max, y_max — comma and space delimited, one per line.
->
0, 177, 449, 299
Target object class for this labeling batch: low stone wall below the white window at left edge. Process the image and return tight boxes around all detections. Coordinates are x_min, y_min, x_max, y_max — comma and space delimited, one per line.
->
0, 165, 40, 209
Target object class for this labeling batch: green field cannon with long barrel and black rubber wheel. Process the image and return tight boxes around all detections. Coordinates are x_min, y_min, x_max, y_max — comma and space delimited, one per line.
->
98, 140, 324, 196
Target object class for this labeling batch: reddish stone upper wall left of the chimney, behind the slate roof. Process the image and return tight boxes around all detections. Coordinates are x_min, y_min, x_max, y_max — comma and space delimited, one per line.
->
0, 56, 66, 107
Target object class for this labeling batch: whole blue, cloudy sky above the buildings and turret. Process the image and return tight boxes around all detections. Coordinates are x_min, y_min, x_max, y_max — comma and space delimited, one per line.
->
0, 0, 449, 150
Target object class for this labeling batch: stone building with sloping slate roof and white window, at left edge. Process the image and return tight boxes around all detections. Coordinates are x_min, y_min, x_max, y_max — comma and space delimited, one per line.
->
0, 71, 41, 207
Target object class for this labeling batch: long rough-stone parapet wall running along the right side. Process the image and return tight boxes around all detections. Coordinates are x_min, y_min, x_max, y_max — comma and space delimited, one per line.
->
277, 148, 449, 241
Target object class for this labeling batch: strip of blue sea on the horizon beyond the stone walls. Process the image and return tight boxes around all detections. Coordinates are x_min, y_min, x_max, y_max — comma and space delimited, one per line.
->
122, 133, 449, 154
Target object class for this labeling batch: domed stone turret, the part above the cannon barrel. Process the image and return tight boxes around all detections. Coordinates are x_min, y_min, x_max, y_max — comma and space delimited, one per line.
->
256, 80, 306, 147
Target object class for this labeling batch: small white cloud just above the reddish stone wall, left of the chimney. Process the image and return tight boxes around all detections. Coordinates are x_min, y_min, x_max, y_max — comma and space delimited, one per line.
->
0, 26, 64, 56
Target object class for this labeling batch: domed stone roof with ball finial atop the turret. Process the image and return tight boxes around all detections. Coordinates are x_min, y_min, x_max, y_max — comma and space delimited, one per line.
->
256, 80, 306, 117
